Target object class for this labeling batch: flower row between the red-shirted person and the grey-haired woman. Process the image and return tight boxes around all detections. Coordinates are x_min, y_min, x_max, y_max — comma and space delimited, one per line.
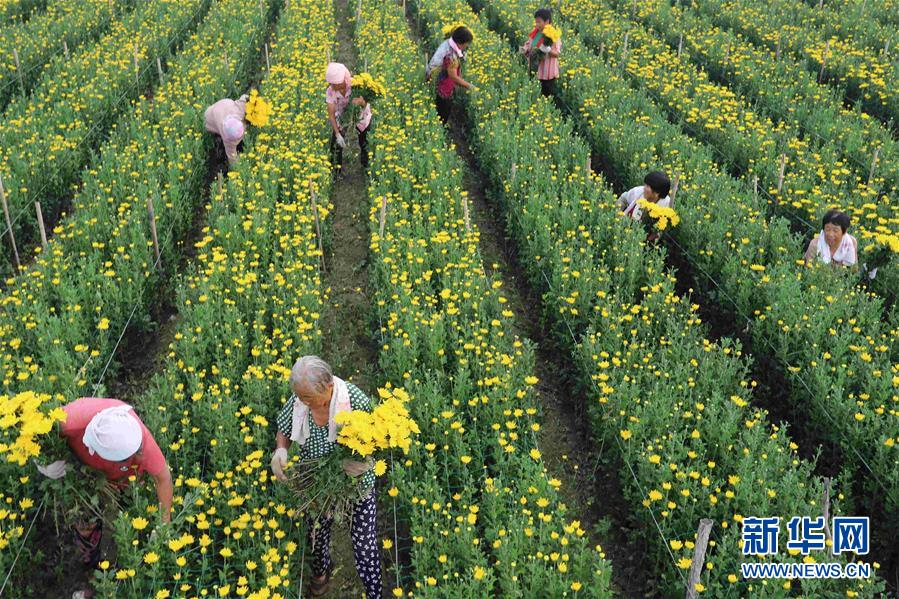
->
85, 0, 349, 599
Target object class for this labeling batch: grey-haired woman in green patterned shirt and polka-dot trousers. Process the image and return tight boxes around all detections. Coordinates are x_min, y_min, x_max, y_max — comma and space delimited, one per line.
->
272, 356, 381, 599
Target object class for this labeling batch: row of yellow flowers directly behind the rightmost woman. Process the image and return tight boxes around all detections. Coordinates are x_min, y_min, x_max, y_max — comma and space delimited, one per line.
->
564, 4, 899, 260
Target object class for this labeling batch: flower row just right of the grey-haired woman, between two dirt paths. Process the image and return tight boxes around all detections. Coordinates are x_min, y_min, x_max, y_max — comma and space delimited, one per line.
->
356, 0, 611, 597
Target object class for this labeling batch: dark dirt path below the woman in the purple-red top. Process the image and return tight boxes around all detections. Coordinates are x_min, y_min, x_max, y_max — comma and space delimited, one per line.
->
438, 101, 656, 598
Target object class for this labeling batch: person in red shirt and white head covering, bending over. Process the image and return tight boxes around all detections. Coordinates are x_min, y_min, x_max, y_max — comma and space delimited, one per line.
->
38, 397, 172, 565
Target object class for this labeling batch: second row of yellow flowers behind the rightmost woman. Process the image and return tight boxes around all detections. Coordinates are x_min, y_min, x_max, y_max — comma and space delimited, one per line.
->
613, 0, 899, 206
